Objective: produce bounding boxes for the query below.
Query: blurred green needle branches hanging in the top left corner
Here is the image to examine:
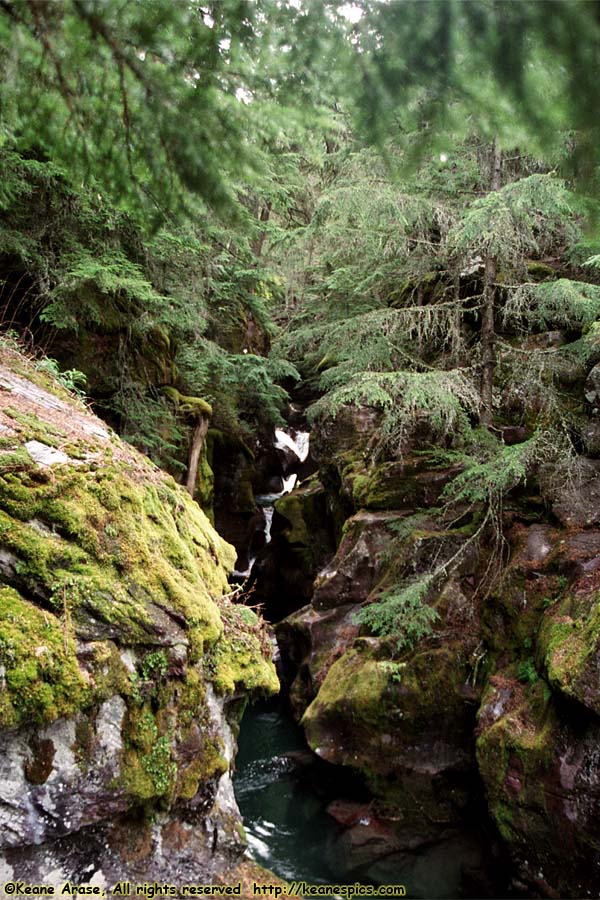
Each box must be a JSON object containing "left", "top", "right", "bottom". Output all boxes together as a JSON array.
[{"left": 0, "top": 0, "right": 338, "bottom": 221}]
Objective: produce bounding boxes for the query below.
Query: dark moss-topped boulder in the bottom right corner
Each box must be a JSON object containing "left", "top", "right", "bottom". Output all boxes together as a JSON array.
[{"left": 477, "top": 669, "right": 600, "bottom": 897}]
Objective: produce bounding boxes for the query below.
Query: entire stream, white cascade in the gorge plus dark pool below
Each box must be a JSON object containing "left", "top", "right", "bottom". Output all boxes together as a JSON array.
[{"left": 233, "top": 429, "right": 514, "bottom": 900}]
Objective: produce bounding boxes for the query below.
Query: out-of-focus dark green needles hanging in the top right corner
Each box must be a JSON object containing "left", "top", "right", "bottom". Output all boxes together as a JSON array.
[{"left": 353, "top": 0, "right": 600, "bottom": 184}]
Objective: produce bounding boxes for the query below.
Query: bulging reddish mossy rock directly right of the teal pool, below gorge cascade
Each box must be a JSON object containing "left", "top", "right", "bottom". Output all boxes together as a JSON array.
[{"left": 277, "top": 492, "right": 488, "bottom": 889}]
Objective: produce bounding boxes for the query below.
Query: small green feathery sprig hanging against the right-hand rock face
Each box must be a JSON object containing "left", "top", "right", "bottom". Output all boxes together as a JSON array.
[{"left": 358, "top": 575, "right": 439, "bottom": 653}]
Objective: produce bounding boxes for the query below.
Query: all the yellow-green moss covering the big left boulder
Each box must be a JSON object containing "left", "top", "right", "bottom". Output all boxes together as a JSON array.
[{"left": 0, "top": 344, "right": 278, "bottom": 780}]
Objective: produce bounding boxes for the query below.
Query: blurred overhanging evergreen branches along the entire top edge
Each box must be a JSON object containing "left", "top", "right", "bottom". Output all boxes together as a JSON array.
[{"left": 0, "top": 0, "right": 600, "bottom": 222}]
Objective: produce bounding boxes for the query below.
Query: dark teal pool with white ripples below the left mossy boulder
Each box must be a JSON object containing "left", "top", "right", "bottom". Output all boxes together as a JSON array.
[{"left": 234, "top": 700, "right": 352, "bottom": 884}]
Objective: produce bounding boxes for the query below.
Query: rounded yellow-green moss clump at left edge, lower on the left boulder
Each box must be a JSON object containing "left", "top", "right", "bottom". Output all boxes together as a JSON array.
[{"left": 0, "top": 587, "right": 93, "bottom": 727}]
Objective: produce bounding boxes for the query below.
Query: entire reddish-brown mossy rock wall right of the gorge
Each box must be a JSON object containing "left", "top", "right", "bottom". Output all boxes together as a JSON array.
[{"left": 277, "top": 398, "right": 600, "bottom": 897}]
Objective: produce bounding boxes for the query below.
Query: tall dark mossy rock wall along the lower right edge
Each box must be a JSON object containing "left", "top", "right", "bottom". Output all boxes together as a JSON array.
[{"left": 476, "top": 525, "right": 600, "bottom": 897}]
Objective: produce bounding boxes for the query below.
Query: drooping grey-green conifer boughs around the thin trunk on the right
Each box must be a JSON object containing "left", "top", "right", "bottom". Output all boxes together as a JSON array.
[{"left": 276, "top": 139, "right": 598, "bottom": 464}]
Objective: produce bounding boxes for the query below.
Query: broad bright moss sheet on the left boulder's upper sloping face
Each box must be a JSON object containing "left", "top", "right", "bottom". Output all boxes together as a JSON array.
[{"left": 0, "top": 458, "right": 234, "bottom": 658}]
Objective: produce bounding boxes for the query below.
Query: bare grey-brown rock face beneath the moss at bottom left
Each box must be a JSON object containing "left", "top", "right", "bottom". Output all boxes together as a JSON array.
[{"left": 0, "top": 698, "right": 243, "bottom": 887}]
